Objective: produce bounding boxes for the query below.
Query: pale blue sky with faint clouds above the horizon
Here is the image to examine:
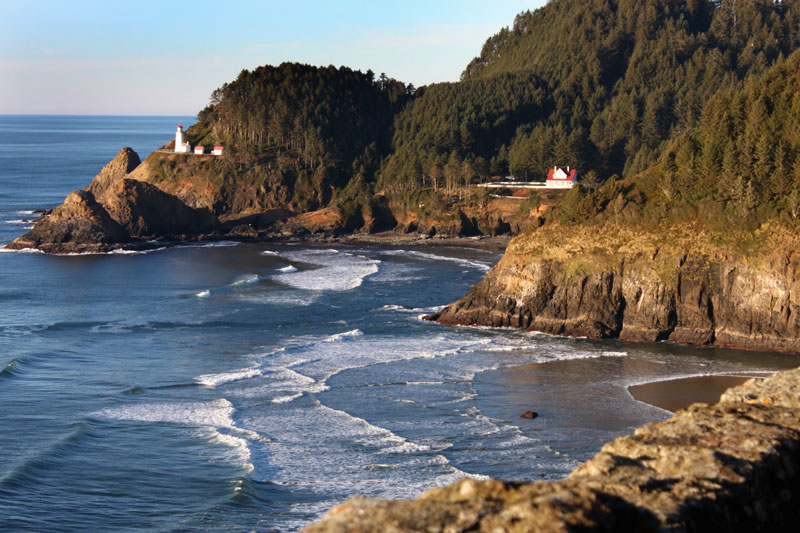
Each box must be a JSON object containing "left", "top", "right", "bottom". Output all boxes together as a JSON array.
[{"left": 0, "top": 0, "right": 546, "bottom": 115}]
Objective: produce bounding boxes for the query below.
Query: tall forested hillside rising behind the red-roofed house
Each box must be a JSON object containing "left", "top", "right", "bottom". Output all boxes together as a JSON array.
[{"left": 381, "top": 0, "right": 800, "bottom": 189}]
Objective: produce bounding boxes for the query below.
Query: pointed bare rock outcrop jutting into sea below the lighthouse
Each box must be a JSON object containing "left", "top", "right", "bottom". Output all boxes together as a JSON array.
[{"left": 6, "top": 148, "right": 217, "bottom": 253}]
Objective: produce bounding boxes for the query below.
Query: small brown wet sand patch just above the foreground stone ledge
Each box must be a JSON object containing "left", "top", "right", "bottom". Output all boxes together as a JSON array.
[{"left": 628, "top": 375, "right": 765, "bottom": 412}]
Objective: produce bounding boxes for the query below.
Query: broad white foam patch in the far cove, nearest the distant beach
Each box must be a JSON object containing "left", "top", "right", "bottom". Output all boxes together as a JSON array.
[{"left": 272, "top": 250, "right": 380, "bottom": 291}]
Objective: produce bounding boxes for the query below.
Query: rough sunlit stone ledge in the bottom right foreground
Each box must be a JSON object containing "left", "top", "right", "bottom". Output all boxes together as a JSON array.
[{"left": 306, "top": 369, "right": 800, "bottom": 533}]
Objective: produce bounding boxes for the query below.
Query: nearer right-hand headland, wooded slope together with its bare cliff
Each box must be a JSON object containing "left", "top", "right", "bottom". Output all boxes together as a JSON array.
[{"left": 434, "top": 46, "right": 800, "bottom": 352}]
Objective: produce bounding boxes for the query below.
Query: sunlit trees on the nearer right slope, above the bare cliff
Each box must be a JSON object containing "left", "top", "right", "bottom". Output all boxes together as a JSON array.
[{"left": 552, "top": 51, "right": 800, "bottom": 233}]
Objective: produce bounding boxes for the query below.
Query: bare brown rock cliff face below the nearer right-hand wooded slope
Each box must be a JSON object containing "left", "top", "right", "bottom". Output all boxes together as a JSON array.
[{"left": 432, "top": 221, "right": 800, "bottom": 352}]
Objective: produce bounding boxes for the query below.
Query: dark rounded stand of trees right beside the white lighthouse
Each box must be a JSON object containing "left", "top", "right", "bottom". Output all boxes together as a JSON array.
[{"left": 188, "top": 63, "right": 414, "bottom": 210}]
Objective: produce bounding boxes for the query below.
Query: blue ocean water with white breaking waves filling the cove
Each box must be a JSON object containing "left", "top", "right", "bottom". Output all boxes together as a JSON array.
[{"left": 0, "top": 116, "right": 798, "bottom": 531}]
